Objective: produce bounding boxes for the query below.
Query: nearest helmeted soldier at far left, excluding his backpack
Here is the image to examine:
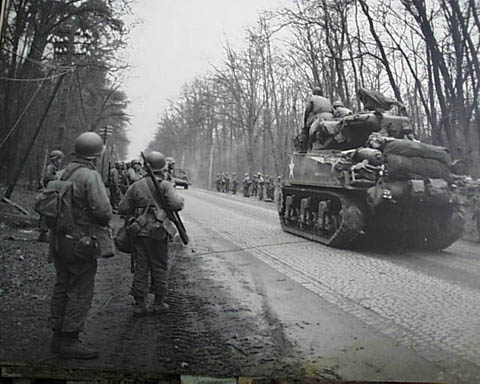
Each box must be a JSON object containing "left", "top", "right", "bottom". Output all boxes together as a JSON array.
[{"left": 50, "top": 132, "right": 112, "bottom": 359}]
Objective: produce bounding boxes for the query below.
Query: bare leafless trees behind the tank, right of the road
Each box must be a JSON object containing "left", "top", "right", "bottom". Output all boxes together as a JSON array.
[{"left": 150, "top": 0, "right": 480, "bottom": 186}]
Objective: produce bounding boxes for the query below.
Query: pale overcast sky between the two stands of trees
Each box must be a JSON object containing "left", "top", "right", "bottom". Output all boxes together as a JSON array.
[{"left": 124, "top": 0, "right": 288, "bottom": 158}]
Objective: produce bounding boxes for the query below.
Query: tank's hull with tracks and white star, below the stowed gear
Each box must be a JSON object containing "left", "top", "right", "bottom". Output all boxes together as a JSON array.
[{"left": 279, "top": 150, "right": 463, "bottom": 250}]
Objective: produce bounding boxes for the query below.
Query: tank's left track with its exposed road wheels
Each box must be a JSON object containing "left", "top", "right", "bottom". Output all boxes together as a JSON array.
[{"left": 279, "top": 187, "right": 365, "bottom": 248}]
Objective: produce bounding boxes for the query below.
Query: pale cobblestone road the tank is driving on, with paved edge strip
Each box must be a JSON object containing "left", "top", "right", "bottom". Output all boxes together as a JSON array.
[{"left": 183, "top": 189, "right": 480, "bottom": 383}]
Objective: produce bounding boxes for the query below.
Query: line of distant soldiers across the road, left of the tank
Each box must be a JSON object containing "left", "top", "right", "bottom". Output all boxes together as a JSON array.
[{"left": 215, "top": 172, "right": 282, "bottom": 201}]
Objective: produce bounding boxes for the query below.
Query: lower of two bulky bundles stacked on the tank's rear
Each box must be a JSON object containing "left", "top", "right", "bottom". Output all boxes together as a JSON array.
[{"left": 384, "top": 153, "right": 450, "bottom": 181}]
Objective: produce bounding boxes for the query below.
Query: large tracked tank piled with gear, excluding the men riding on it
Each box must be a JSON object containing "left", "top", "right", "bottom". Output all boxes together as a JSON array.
[{"left": 278, "top": 91, "right": 464, "bottom": 250}]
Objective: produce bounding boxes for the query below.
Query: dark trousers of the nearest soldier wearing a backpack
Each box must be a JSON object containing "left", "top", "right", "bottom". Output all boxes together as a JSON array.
[{"left": 50, "top": 234, "right": 97, "bottom": 332}]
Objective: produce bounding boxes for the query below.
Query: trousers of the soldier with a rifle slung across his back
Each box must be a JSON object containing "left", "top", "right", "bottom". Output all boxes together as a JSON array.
[{"left": 131, "top": 237, "right": 168, "bottom": 299}]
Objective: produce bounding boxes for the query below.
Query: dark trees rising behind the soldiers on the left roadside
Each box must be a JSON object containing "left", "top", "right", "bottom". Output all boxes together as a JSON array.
[{"left": 0, "top": 0, "right": 130, "bottom": 197}]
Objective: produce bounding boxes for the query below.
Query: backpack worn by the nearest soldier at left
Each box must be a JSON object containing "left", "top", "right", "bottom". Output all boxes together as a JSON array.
[{"left": 34, "top": 164, "right": 84, "bottom": 233}]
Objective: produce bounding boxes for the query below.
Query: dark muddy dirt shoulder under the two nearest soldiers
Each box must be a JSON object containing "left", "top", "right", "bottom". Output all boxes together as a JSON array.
[{"left": 0, "top": 188, "right": 301, "bottom": 377}]
